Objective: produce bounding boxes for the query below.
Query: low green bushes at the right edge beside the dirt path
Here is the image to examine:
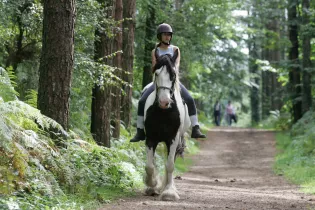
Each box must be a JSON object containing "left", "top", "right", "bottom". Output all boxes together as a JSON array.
[{"left": 275, "top": 112, "right": 315, "bottom": 193}]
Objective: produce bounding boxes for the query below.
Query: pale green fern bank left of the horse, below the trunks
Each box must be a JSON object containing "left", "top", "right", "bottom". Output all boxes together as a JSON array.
[{"left": 0, "top": 101, "right": 144, "bottom": 209}]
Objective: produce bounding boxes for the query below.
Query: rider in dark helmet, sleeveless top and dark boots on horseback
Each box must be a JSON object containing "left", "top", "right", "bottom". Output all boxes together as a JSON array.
[{"left": 130, "top": 23, "right": 206, "bottom": 142}]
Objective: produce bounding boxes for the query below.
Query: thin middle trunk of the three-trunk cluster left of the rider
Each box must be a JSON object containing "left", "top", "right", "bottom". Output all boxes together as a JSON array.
[{"left": 112, "top": 0, "right": 123, "bottom": 138}]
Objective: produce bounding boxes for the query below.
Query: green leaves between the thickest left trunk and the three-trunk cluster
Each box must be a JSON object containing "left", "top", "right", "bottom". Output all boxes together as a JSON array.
[{"left": 70, "top": 0, "right": 128, "bottom": 139}]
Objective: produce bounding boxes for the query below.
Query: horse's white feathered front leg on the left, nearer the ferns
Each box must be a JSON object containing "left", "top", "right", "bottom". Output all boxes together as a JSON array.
[{"left": 145, "top": 146, "right": 161, "bottom": 195}]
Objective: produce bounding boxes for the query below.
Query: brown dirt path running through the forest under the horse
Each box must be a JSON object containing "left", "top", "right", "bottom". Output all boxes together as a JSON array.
[{"left": 102, "top": 127, "right": 315, "bottom": 210}]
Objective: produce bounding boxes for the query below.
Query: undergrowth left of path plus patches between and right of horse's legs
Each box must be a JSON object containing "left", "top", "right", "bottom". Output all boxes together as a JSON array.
[{"left": 0, "top": 68, "right": 198, "bottom": 210}]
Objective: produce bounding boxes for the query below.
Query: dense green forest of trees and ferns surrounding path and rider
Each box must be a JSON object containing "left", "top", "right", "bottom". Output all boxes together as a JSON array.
[{"left": 0, "top": 0, "right": 315, "bottom": 209}]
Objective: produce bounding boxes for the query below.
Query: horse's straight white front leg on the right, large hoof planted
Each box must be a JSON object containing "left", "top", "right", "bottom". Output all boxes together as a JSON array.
[{"left": 160, "top": 133, "right": 179, "bottom": 201}]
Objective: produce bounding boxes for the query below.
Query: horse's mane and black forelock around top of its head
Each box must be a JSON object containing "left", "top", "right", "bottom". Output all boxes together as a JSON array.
[{"left": 153, "top": 54, "right": 180, "bottom": 90}]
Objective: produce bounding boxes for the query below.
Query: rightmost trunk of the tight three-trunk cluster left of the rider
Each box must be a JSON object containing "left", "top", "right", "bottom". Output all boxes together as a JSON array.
[{"left": 121, "top": 0, "right": 136, "bottom": 128}]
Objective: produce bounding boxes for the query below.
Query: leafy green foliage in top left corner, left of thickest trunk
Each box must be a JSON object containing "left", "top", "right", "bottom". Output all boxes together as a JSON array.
[{"left": 0, "top": 0, "right": 43, "bottom": 98}]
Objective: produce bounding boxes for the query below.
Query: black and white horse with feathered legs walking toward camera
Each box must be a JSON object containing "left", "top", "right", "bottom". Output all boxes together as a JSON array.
[{"left": 144, "top": 51, "right": 190, "bottom": 200}]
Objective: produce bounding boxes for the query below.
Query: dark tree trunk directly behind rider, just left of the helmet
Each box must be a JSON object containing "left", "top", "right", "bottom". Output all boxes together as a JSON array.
[{"left": 142, "top": 3, "right": 157, "bottom": 88}]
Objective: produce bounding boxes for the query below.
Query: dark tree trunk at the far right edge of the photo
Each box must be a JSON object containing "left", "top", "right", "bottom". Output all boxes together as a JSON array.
[{"left": 302, "top": 0, "right": 312, "bottom": 114}]
